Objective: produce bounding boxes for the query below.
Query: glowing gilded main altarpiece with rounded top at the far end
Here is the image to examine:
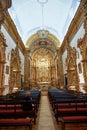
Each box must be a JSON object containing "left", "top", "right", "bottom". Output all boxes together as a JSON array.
[{"left": 31, "top": 48, "right": 56, "bottom": 88}]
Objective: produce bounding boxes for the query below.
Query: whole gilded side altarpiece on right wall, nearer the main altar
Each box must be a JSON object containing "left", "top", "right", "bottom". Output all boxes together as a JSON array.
[{"left": 66, "top": 45, "right": 78, "bottom": 91}]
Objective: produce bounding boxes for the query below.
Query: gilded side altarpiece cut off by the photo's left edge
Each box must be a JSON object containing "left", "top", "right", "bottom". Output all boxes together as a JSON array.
[{"left": 0, "top": 31, "right": 7, "bottom": 91}]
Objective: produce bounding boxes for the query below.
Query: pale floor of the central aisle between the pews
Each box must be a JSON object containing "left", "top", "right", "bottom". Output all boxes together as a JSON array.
[{"left": 38, "top": 96, "right": 55, "bottom": 130}]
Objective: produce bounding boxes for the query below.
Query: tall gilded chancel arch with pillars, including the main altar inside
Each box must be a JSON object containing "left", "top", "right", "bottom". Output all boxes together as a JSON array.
[{"left": 24, "top": 30, "right": 63, "bottom": 89}]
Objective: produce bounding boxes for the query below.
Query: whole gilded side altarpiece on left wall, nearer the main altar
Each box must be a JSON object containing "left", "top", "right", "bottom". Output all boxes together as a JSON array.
[{"left": 9, "top": 46, "right": 21, "bottom": 91}]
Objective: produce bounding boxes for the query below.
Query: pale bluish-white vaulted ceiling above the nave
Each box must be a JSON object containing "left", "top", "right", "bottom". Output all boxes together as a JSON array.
[{"left": 9, "top": 0, "right": 80, "bottom": 44}]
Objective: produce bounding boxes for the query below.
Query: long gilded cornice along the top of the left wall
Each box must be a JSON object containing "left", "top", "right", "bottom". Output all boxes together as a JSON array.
[{"left": 4, "top": 13, "right": 25, "bottom": 54}]
